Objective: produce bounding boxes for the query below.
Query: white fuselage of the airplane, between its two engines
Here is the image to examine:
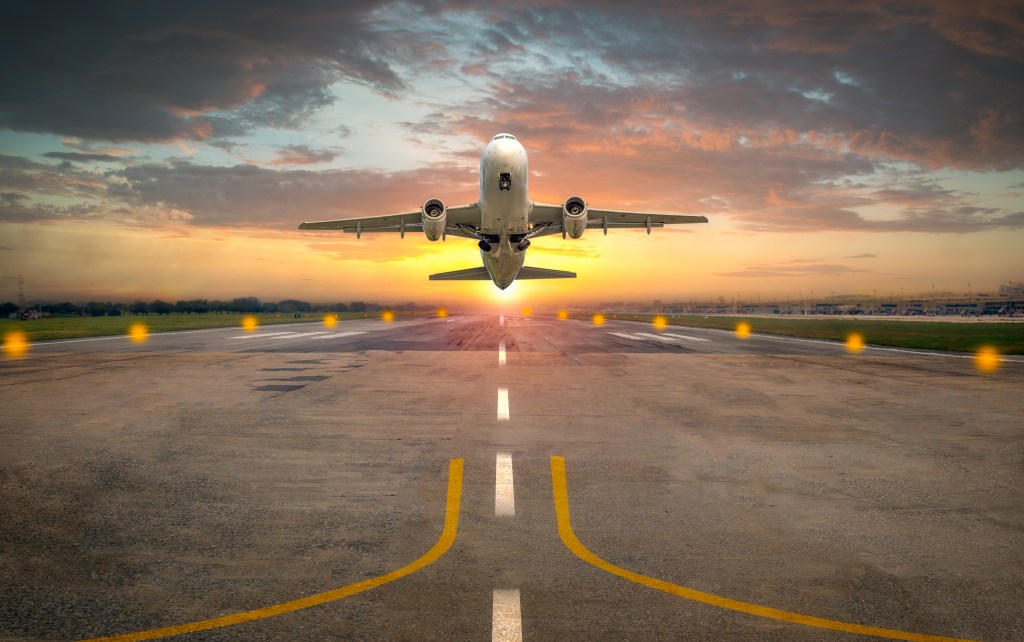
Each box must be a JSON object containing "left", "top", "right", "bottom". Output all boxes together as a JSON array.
[{"left": 479, "top": 134, "right": 532, "bottom": 290}]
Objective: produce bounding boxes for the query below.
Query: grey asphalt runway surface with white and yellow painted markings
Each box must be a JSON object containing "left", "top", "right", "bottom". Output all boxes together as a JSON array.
[{"left": 0, "top": 313, "right": 1024, "bottom": 642}]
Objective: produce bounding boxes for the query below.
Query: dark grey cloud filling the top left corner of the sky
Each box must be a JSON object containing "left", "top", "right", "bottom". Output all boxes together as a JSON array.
[{"left": 0, "top": 0, "right": 403, "bottom": 141}]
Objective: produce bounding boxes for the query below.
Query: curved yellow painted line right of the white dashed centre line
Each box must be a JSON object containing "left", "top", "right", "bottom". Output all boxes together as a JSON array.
[{"left": 551, "top": 457, "right": 969, "bottom": 642}]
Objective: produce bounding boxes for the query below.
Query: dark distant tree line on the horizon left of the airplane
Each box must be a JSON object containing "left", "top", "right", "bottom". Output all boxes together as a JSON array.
[{"left": 0, "top": 297, "right": 428, "bottom": 318}]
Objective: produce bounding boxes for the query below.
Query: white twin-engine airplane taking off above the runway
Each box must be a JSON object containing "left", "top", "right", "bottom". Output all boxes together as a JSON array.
[{"left": 299, "top": 134, "right": 708, "bottom": 290}]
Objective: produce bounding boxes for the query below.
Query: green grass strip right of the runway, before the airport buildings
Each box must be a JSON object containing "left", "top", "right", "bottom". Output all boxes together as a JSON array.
[{"left": 585, "top": 314, "right": 1024, "bottom": 354}]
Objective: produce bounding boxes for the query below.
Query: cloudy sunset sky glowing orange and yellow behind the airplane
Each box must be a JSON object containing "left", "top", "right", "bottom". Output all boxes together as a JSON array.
[{"left": 0, "top": 0, "right": 1024, "bottom": 305}]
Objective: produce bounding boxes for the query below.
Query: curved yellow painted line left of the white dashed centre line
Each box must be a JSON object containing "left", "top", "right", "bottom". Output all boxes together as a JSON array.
[{"left": 82, "top": 459, "right": 463, "bottom": 642}]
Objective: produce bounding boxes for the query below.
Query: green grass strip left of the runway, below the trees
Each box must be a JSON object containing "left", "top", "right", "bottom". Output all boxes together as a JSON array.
[{"left": 0, "top": 312, "right": 414, "bottom": 343}]
